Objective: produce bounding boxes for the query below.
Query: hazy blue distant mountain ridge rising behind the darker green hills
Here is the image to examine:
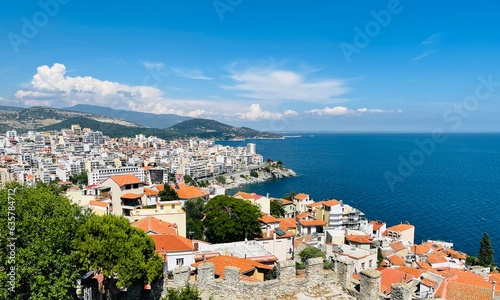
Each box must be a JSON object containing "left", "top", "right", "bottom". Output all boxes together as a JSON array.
[{"left": 66, "top": 104, "right": 191, "bottom": 128}]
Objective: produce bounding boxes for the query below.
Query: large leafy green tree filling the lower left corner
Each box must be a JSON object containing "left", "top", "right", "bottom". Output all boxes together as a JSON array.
[{"left": 0, "top": 183, "right": 90, "bottom": 300}]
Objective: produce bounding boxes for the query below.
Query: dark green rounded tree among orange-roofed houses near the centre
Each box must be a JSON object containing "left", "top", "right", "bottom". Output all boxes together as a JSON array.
[{"left": 203, "top": 195, "right": 262, "bottom": 243}]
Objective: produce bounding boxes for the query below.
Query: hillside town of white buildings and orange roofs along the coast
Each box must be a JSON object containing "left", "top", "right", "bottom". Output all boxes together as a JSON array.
[{"left": 0, "top": 125, "right": 500, "bottom": 300}]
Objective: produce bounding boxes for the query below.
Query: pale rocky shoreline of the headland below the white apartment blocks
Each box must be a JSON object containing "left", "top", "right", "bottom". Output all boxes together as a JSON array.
[{"left": 218, "top": 163, "right": 297, "bottom": 189}]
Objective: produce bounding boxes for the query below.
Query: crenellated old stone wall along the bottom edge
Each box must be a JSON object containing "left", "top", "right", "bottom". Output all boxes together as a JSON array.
[{"left": 174, "top": 258, "right": 354, "bottom": 300}]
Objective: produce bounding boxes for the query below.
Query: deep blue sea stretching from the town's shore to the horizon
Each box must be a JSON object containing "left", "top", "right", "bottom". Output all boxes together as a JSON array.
[{"left": 217, "top": 133, "right": 500, "bottom": 262}]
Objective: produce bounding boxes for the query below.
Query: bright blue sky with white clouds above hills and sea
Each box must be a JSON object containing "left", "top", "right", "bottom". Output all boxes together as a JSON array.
[{"left": 0, "top": 0, "right": 500, "bottom": 132}]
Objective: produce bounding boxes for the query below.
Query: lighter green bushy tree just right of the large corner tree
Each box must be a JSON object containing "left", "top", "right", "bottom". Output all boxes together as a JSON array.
[{"left": 73, "top": 215, "right": 163, "bottom": 293}]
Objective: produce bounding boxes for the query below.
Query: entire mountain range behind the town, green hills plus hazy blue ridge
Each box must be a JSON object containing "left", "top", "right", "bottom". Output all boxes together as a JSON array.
[{"left": 0, "top": 105, "right": 281, "bottom": 140}]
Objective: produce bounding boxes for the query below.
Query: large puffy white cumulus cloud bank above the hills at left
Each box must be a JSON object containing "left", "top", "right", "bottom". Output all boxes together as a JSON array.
[{"left": 15, "top": 63, "right": 218, "bottom": 116}]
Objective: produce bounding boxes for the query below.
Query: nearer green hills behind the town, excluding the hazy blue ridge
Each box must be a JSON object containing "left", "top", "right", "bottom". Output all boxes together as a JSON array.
[{"left": 0, "top": 106, "right": 281, "bottom": 140}]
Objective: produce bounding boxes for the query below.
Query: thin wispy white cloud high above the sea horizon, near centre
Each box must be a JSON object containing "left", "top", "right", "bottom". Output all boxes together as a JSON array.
[{"left": 222, "top": 69, "right": 349, "bottom": 103}]
